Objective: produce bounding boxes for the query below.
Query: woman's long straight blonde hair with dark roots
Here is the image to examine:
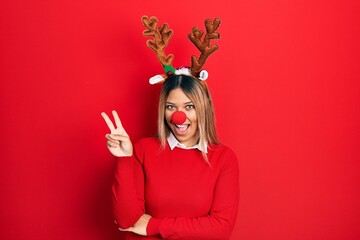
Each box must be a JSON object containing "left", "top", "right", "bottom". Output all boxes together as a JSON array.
[{"left": 158, "top": 75, "right": 219, "bottom": 160}]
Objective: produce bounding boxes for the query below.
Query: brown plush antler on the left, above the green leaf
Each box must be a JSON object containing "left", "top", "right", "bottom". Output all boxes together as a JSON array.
[{"left": 141, "top": 16, "right": 174, "bottom": 66}]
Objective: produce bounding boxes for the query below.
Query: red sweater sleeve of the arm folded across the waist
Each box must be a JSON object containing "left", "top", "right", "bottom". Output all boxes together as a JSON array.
[{"left": 147, "top": 149, "right": 239, "bottom": 239}]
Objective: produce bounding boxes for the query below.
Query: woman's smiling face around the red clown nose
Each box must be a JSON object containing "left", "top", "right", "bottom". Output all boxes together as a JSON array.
[{"left": 165, "top": 88, "right": 199, "bottom": 147}]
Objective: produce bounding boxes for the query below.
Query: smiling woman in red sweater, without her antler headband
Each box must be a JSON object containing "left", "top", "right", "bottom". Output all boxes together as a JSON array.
[{"left": 102, "top": 75, "right": 239, "bottom": 239}]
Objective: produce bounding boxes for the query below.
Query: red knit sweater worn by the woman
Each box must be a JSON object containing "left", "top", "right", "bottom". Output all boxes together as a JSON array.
[{"left": 112, "top": 138, "right": 239, "bottom": 240}]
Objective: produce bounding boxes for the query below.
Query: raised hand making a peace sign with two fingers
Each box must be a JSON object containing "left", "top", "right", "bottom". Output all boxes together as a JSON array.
[{"left": 101, "top": 110, "right": 133, "bottom": 157}]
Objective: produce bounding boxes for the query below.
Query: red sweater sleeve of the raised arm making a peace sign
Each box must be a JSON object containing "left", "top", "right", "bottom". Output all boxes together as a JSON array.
[{"left": 112, "top": 142, "right": 145, "bottom": 228}]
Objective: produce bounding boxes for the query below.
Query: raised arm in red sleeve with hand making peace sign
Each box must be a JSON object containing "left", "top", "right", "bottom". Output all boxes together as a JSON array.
[{"left": 101, "top": 111, "right": 144, "bottom": 228}]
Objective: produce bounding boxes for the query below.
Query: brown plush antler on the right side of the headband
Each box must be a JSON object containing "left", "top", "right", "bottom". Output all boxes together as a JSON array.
[{"left": 188, "top": 18, "right": 221, "bottom": 76}]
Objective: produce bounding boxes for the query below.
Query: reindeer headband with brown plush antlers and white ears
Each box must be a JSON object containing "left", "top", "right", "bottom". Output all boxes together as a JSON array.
[{"left": 142, "top": 16, "right": 221, "bottom": 84}]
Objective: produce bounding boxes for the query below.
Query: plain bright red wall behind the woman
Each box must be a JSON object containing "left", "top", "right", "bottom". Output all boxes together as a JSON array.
[{"left": 0, "top": 0, "right": 360, "bottom": 240}]
